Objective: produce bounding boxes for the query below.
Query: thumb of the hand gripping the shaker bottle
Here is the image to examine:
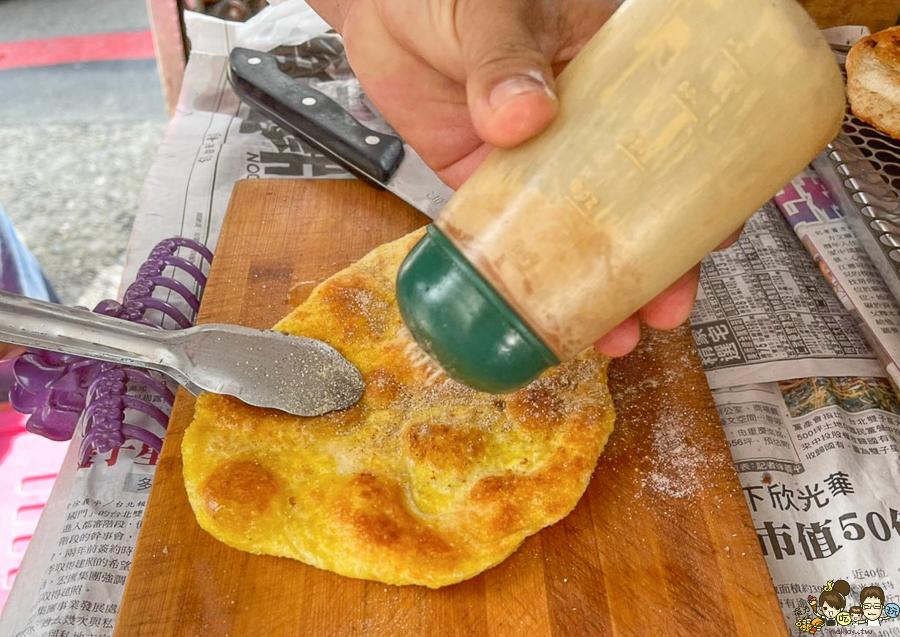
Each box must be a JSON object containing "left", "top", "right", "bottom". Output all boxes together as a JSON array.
[{"left": 458, "top": 0, "right": 559, "bottom": 148}]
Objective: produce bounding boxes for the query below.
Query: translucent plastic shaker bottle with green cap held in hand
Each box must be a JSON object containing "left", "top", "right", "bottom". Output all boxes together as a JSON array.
[{"left": 397, "top": 0, "right": 844, "bottom": 393}]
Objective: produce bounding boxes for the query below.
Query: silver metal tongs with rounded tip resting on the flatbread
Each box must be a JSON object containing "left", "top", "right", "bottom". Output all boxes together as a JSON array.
[{"left": 0, "top": 291, "right": 365, "bottom": 416}]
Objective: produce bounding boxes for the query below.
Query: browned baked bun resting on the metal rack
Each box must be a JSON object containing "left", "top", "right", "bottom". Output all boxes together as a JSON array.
[{"left": 847, "top": 27, "right": 900, "bottom": 139}]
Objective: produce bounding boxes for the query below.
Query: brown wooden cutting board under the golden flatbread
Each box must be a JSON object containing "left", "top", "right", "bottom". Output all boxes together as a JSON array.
[{"left": 115, "top": 181, "right": 787, "bottom": 637}]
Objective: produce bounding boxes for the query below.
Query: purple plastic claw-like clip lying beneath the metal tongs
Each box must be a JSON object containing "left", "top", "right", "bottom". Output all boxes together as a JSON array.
[{"left": 10, "top": 238, "right": 213, "bottom": 466}]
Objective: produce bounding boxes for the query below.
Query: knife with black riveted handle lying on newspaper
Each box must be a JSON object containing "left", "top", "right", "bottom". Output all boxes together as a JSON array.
[{"left": 229, "top": 48, "right": 453, "bottom": 219}]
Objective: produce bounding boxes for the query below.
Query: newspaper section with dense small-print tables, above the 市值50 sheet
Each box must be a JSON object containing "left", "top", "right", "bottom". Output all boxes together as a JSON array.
[{"left": 691, "top": 203, "right": 884, "bottom": 388}]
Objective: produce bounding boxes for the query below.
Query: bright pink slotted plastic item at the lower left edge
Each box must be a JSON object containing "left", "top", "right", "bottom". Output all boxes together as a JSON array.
[{"left": 0, "top": 403, "right": 68, "bottom": 610}]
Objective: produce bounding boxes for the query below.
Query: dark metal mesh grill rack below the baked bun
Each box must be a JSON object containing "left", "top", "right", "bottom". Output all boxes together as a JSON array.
[{"left": 813, "top": 46, "right": 900, "bottom": 301}]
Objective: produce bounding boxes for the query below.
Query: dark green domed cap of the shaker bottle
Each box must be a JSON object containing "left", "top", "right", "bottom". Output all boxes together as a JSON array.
[{"left": 397, "top": 225, "right": 559, "bottom": 394}]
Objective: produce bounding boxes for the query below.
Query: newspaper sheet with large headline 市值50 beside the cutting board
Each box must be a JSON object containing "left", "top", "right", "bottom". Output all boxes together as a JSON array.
[{"left": 713, "top": 377, "right": 900, "bottom": 635}]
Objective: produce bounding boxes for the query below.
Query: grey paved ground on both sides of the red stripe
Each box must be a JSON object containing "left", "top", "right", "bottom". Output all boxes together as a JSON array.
[{"left": 0, "top": 0, "right": 167, "bottom": 306}]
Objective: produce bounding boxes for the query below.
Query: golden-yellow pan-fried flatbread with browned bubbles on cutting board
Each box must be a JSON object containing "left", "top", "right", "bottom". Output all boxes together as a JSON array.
[{"left": 182, "top": 231, "right": 614, "bottom": 587}]
